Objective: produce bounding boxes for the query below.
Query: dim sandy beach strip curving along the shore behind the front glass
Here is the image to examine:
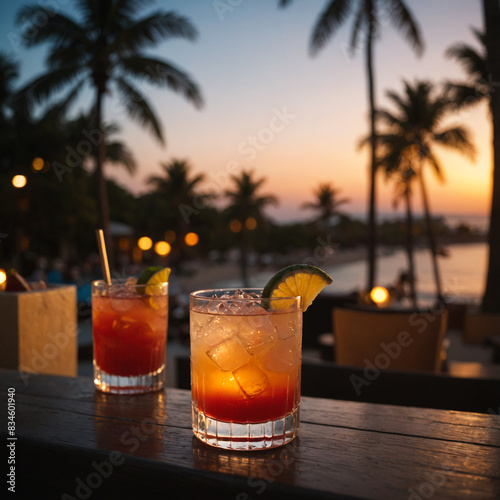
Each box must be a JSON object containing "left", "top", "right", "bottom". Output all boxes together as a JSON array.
[{"left": 172, "top": 248, "right": 366, "bottom": 293}]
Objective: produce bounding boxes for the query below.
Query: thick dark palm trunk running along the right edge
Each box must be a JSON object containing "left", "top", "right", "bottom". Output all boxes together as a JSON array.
[{"left": 481, "top": 0, "right": 500, "bottom": 313}]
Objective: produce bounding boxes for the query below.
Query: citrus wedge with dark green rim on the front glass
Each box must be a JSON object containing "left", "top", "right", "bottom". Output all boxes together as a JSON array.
[{"left": 262, "top": 264, "right": 332, "bottom": 311}]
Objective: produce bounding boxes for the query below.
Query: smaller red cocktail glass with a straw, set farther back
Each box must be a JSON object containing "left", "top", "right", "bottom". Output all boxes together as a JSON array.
[{"left": 92, "top": 278, "right": 168, "bottom": 394}]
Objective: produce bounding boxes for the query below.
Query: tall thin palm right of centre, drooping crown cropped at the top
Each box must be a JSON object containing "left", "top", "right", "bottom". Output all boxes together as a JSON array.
[{"left": 280, "top": 0, "right": 423, "bottom": 290}]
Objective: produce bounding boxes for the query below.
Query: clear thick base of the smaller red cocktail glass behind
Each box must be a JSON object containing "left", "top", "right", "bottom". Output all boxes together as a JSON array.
[{"left": 94, "top": 361, "right": 165, "bottom": 394}]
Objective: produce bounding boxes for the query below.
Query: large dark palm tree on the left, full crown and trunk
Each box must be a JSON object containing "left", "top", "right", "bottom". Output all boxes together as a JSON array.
[{"left": 18, "top": 0, "right": 202, "bottom": 258}]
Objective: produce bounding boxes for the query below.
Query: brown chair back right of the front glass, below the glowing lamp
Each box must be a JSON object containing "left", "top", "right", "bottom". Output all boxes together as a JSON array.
[{"left": 333, "top": 308, "right": 448, "bottom": 372}]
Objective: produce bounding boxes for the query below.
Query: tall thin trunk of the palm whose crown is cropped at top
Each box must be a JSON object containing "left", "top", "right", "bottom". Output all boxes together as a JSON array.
[{"left": 366, "top": 9, "right": 377, "bottom": 291}]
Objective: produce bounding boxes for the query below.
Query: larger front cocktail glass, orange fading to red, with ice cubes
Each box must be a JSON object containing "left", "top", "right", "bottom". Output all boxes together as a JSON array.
[{"left": 190, "top": 289, "right": 302, "bottom": 450}]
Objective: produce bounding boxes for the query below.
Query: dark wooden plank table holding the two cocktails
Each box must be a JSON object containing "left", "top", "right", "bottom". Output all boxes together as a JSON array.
[{"left": 0, "top": 371, "right": 500, "bottom": 500}]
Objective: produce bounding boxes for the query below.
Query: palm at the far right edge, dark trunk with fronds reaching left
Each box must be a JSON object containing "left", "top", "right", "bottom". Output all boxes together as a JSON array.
[{"left": 446, "top": 6, "right": 500, "bottom": 313}]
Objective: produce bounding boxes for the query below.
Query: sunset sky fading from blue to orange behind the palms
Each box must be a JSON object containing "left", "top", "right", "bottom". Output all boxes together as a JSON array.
[{"left": 0, "top": 0, "right": 491, "bottom": 221}]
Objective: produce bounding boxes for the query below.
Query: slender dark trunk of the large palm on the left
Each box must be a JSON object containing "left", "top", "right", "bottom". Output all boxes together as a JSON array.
[{"left": 95, "top": 85, "right": 114, "bottom": 268}]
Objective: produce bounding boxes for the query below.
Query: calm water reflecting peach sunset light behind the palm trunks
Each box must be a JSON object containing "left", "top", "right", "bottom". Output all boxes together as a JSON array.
[{"left": 222, "top": 243, "right": 488, "bottom": 306}]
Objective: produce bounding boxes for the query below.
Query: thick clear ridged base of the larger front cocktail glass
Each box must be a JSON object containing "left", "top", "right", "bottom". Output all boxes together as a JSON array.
[{"left": 192, "top": 403, "right": 300, "bottom": 451}]
